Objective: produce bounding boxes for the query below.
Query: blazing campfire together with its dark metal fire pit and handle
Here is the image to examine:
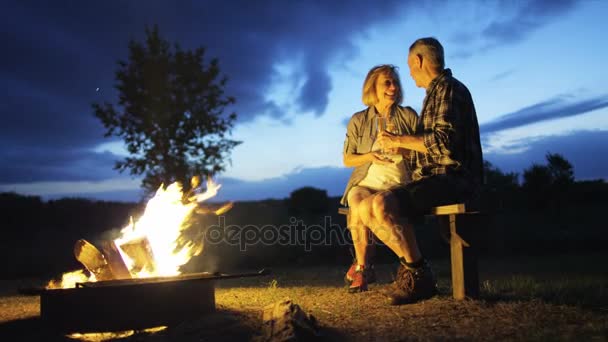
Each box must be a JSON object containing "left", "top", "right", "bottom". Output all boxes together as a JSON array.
[{"left": 27, "top": 178, "right": 268, "bottom": 332}]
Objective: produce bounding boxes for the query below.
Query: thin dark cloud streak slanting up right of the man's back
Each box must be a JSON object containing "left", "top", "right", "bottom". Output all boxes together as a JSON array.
[{"left": 480, "top": 95, "right": 608, "bottom": 135}]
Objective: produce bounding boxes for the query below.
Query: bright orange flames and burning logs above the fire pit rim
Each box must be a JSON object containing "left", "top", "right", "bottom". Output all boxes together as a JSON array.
[{"left": 47, "top": 177, "right": 232, "bottom": 289}]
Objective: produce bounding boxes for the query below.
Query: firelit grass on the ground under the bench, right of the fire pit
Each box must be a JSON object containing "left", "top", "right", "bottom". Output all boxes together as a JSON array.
[{"left": 207, "top": 255, "right": 608, "bottom": 340}]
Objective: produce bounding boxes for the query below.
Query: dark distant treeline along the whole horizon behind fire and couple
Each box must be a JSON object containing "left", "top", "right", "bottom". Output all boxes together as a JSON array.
[{"left": 0, "top": 154, "right": 608, "bottom": 277}]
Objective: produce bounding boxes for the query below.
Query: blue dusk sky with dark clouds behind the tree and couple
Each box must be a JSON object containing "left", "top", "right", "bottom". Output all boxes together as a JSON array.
[{"left": 0, "top": 0, "right": 608, "bottom": 200}]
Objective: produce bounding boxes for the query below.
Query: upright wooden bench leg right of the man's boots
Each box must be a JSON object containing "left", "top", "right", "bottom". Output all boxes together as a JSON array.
[{"left": 449, "top": 214, "right": 479, "bottom": 300}]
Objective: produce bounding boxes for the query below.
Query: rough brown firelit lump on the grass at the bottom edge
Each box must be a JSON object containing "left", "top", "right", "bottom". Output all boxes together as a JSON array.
[{"left": 262, "top": 299, "right": 320, "bottom": 342}]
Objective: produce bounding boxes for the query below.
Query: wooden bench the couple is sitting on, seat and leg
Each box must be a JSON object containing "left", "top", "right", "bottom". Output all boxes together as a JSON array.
[{"left": 338, "top": 203, "right": 479, "bottom": 300}]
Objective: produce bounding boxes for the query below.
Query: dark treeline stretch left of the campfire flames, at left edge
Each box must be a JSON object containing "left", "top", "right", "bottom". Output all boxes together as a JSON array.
[{"left": 0, "top": 193, "right": 140, "bottom": 277}]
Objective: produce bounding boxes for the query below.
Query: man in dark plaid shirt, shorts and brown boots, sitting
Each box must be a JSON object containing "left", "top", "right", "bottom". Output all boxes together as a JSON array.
[{"left": 361, "top": 38, "right": 483, "bottom": 305}]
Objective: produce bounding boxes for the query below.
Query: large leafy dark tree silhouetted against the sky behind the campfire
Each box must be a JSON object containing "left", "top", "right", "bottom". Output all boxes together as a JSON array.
[{"left": 93, "top": 26, "right": 240, "bottom": 192}]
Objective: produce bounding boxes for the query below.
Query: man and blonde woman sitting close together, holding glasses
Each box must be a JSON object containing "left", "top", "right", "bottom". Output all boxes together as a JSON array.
[{"left": 341, "top": 38, "right": 483, "bottom": 305}]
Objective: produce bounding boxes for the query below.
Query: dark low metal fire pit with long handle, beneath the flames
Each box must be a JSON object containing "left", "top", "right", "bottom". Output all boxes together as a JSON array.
[{"left": 29, "top": 270, "right": 269, "bottom": 332}]
